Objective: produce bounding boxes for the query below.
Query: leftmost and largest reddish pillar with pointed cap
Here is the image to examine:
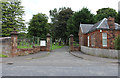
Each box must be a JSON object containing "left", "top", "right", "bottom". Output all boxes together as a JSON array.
[{"left": 11, "top": 28, "right": 18, "bottom": 57}]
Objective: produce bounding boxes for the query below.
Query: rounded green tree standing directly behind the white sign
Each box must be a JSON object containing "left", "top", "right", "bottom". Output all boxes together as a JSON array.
[{"left": 28, "top": 13, "right": 48, "bottom": 38}]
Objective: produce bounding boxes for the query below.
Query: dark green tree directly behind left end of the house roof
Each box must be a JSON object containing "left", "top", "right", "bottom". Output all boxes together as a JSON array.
[{"left": 66, "top": 8, "right": 95, "bottom": 40}]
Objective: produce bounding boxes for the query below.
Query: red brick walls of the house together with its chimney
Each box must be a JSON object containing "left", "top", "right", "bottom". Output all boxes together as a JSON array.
[{"left": 79, "top": 17, "right": 120, "bottom": 49}]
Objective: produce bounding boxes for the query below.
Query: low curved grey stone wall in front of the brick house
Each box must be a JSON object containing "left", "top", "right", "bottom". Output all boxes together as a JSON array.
[{"left": 81, "top": 46, "right": 120, "bottom": 58}]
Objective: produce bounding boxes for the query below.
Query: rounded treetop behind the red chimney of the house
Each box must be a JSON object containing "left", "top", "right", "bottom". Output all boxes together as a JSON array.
[{"left": 95, "top": 8, "right": 117, "bottom": 22}]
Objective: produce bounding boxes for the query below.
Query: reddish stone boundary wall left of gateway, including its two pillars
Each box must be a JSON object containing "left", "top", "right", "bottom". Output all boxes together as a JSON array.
[{"left": 0, "top": 28, "right": 51, "bottom": 57}]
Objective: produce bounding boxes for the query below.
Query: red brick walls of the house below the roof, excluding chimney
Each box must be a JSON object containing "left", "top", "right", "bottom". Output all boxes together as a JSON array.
[{"left": 79, "top": 30, "right": 120, "bottom": 49}]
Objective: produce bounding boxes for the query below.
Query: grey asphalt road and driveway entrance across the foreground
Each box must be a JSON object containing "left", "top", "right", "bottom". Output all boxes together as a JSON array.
[{"left": 2, "top": 46, "right": 118, "bottom": 76}]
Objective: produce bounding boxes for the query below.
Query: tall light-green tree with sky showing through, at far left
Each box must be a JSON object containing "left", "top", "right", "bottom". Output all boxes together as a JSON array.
[{"left": 1, "top": 0, "right": 26, "bottom": 37}]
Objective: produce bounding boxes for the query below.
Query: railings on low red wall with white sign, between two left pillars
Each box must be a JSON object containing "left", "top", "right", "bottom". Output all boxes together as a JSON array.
[{"left": 17, "top": 37, "right": 50, "bottom": 55}]
